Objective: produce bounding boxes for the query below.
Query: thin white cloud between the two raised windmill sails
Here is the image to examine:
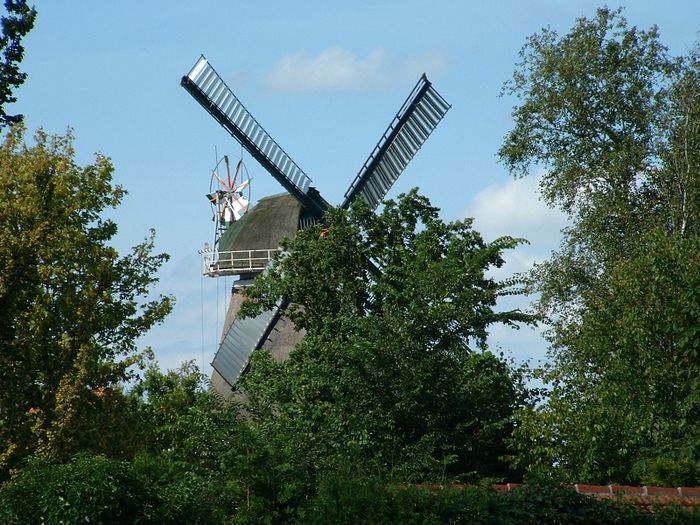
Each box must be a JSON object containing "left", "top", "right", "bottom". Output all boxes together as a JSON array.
[{"left": 266, "top": 47, "right": 447, "bottom": 92}]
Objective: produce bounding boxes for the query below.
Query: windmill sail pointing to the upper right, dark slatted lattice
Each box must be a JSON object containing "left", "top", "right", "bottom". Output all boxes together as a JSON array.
[{"left": 341, "top": 74, "right": 450, "bottom": 209}]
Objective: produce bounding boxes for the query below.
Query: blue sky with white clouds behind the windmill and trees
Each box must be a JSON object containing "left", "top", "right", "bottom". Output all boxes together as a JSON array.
[{"left": 8, "top": 0, "right": 700, "bottom": 368}]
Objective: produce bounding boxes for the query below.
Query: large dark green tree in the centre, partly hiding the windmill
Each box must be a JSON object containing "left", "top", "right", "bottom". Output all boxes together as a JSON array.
[{"left": 232, "top": 192, "right": 532, "bottom": 516}]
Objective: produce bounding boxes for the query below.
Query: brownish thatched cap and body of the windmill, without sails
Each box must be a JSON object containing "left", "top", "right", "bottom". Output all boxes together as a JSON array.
[{"left": 211, "top": 193, "right": 304, "bottom": 399}]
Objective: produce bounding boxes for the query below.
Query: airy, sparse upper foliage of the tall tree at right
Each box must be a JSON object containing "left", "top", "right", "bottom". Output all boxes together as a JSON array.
[{"left": 499, "top": 9, "right": 700, "bottom": 324}]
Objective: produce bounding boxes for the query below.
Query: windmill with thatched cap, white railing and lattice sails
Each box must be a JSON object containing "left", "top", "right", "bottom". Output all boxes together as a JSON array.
[{"left": 181, "top": 56, "right": 450, "bottom": 396}]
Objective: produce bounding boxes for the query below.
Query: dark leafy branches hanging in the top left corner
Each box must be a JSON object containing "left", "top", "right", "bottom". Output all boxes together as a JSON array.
[{"left": 0, "top": 0, "right": 36, "bottom": 129}]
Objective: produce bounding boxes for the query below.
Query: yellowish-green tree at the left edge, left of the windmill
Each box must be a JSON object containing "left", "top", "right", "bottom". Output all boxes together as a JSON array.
[{"left": 0, "top": 126, "right": 171, "bottom": 476}]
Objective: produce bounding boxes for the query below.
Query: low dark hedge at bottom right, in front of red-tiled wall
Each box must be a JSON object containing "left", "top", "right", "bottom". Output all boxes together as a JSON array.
[{"left": 297, "top": 476, "right": 698, "bottom": 525}]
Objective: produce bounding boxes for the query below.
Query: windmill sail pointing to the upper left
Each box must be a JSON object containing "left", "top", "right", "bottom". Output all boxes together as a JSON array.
[{"left": 180, "top": 56, "right": 328, "bottom": 219}]
